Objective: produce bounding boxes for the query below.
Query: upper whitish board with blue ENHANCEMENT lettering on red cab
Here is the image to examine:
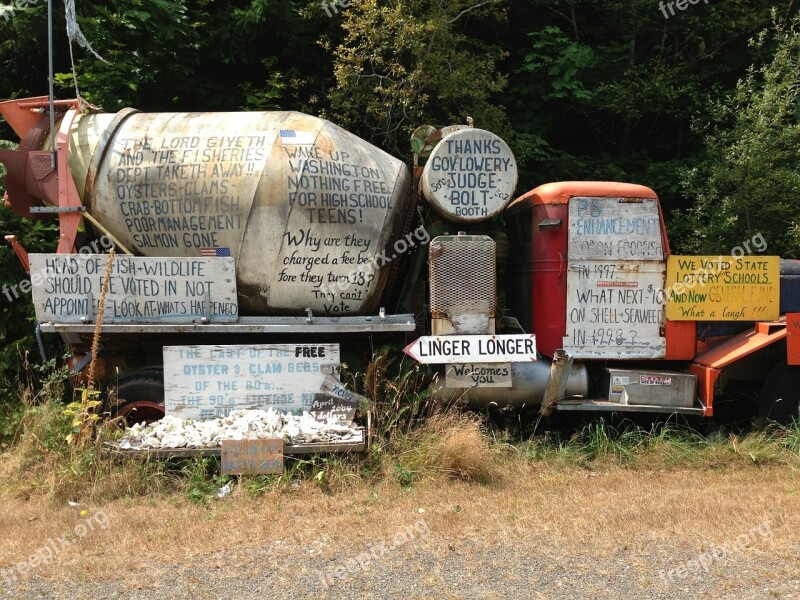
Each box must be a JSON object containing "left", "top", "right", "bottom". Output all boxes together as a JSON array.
[{"left": 568, "top": 198, "right": 664, "bottom": 261}]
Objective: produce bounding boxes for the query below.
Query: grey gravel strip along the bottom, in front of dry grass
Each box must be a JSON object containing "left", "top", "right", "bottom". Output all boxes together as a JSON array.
[{"left": 0, "top": 521, "right": 800, "bottom": 600}]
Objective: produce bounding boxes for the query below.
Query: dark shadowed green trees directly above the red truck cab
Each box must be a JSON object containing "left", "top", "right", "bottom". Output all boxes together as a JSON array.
[{"left": 502, "top": 0, "right": 788, "bottom": 200}]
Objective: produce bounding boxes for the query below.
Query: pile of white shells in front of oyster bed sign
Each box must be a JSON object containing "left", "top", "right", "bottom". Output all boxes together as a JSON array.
[{"left": 119, "top": 408, "right": 361, "bottom": 450}]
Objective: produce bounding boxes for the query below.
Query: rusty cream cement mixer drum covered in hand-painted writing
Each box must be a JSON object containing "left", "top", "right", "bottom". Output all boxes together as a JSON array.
[{"left": 62, "top": 110, "right": 410, "bottom": 315}]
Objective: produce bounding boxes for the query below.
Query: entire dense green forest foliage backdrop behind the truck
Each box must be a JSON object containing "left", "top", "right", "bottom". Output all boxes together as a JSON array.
[{"left": 0, "top": 0, "right": 800, "bottom": 406}]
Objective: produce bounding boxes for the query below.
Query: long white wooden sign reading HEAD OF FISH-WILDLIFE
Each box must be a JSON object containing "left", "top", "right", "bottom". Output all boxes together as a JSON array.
[{"left": 30, "top": 254, "right": 239, "bottom": 323}]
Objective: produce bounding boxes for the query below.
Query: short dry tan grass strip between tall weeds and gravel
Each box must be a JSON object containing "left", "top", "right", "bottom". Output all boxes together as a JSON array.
[{"left": 0, "top": 465, "right": 800, "bottom": 584}]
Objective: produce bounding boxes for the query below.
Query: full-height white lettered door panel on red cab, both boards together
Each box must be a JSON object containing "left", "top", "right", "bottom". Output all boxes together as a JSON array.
[{"left": 563, "top": 197, "right": 666, "bottom": 359}]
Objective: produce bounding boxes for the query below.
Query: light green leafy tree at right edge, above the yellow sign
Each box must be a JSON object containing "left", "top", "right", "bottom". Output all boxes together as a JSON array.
[{"left": 677, "top": 17, "right": 800, "bottom": 253}]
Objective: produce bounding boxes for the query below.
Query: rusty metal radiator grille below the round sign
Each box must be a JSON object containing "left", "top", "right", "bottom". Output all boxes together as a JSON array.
[{"left": 428, "top": 235, "right": 497, "bottom": 318}]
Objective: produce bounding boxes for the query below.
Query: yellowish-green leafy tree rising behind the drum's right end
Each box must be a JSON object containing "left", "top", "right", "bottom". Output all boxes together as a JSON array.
[{"left": 331, "top": 0, "right": 506, "bottom": 155}]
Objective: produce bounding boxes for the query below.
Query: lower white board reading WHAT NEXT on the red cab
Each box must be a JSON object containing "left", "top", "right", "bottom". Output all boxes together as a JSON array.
[{"left": 563, "top": 260, "right": 666, "bottom": 358}]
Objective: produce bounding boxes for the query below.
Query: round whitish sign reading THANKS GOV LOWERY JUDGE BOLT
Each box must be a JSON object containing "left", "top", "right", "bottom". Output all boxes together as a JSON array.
[{"left": 422, "top": 129, "right": 517, "bottom": 223}]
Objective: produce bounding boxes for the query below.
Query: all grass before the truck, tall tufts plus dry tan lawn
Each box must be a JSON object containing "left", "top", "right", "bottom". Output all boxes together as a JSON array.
[{"left": 0, "top": 398, "right": 800, "bottom": 588}]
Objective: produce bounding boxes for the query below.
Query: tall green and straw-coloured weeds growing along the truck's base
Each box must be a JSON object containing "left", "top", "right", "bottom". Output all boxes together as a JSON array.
[{"left": 0, "top": 360, "right": 800, "bottom": 504}]
